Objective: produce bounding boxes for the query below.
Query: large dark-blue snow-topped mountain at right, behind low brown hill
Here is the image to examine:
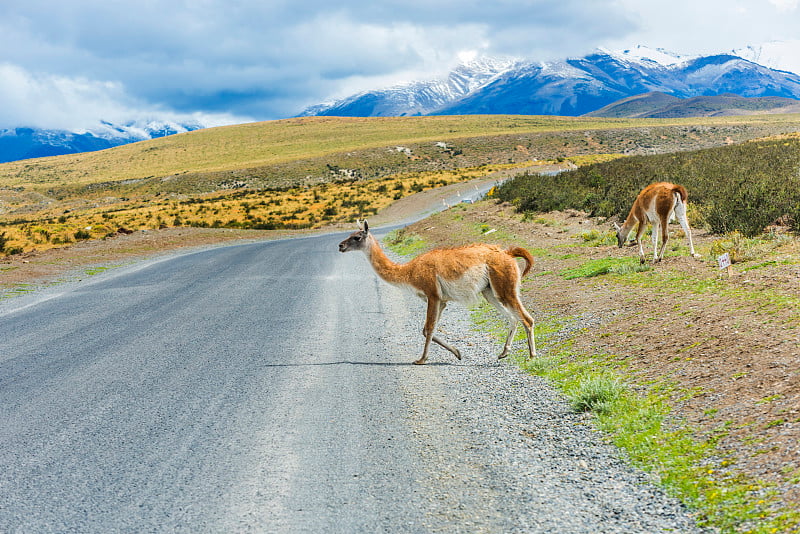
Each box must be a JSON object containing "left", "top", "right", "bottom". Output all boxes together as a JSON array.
[{"left": 438, "top": 52, "right": 800, "bottom": 115}]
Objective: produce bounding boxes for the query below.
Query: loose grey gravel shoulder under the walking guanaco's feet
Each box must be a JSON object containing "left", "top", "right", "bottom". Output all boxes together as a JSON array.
[{"left": 387, "top": 249, "right": 708, "bottom": 534}]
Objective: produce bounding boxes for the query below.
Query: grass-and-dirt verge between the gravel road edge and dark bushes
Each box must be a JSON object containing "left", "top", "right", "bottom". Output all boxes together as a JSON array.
[{"left": 394, "top": 203, "right": 800, "bottom": 534}]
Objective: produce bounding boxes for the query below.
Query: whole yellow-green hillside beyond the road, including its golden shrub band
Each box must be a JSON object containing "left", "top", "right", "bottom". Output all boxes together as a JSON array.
[{"left": 0, "top": 115, "right": 800, "bottom": 254}]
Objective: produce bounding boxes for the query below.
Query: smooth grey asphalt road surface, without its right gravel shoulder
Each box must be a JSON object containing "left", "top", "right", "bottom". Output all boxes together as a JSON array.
[{"left": 0, "top": 231, "right": 444, "bottom": 532}]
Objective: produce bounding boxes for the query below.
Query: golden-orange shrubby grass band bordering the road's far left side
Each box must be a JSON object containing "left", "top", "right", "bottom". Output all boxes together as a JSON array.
[{"left": 2, "top": 161, "right": 536, "bottom": 253}]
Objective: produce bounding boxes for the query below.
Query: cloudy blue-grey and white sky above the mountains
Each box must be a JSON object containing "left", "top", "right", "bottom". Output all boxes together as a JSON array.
[{"left": 0, "top": 0, "right": 800, "bottom": 129}]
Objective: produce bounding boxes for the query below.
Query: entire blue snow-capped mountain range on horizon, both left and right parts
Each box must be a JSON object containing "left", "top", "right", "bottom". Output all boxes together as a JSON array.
[{"left": 0, "top": 41, "right": 800, "bottom": 162}]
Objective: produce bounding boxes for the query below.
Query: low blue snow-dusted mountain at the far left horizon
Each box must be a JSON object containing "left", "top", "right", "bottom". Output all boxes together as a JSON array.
[{"left": 0, "top": 119, "right": 206, "bottom": 163}]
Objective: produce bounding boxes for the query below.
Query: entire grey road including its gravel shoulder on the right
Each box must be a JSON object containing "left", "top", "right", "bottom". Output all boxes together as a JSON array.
[{"left": 0, "top": 226, "right": 693, "bottom": 533}]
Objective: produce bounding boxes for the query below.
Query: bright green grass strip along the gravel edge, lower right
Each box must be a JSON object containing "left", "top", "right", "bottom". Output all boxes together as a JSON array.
[{"left": 473, "top": 306, "right": 800, "bottom": 534}]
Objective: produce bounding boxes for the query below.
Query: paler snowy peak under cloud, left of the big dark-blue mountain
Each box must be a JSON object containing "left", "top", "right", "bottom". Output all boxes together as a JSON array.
[{"left": 300, "top": 58, "right": 515, "bottom": 117}]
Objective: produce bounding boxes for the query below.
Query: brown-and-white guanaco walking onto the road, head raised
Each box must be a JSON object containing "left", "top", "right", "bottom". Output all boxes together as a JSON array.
[{"left": 339, "top": 220, "right": 536, "bottom": 365}]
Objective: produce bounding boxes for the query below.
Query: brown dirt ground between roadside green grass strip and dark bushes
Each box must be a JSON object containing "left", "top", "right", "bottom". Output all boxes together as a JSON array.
[{"left": 409, "top": 201, "right": 800, "bottom": 507}]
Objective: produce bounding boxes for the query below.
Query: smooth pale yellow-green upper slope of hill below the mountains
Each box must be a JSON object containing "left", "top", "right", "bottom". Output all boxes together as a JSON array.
[{"left": 0, "top": 114, "right": 800, "bottom": 187}]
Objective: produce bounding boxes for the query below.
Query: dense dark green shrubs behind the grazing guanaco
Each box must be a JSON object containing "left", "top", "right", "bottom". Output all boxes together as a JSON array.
[{"left": 497, "top": 138, "right": 800, "bottom": 236}]
